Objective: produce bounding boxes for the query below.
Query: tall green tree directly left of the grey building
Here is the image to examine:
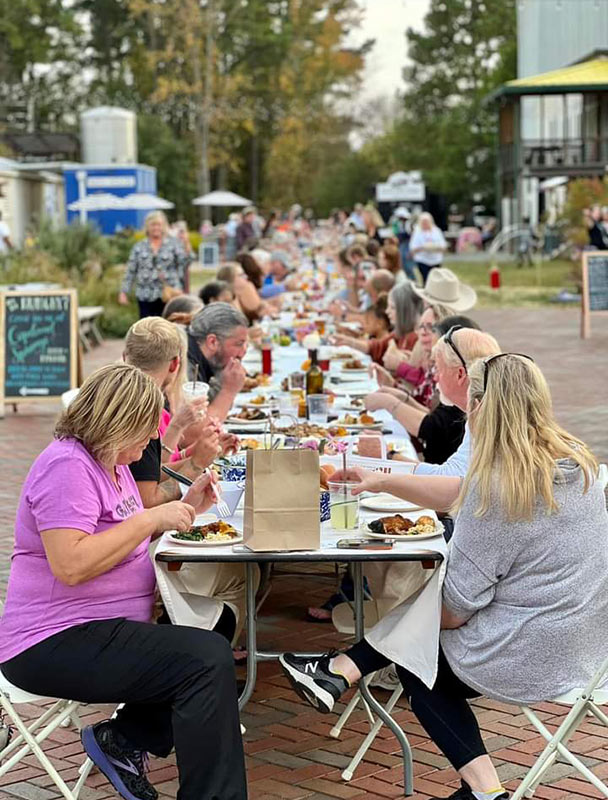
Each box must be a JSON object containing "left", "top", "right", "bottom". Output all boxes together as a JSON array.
[{"left": 398, "top": 0, "right": 516, "bottom": 211}]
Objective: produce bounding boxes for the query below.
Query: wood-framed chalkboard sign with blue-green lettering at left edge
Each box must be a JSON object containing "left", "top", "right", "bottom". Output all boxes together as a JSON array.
[{"left": 0, "top": 289, "right": 78, "bottom": 404}]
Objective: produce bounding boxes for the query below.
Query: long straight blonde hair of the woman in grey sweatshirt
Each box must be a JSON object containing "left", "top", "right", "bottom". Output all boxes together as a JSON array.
[{"left": 455, "top": 354, "right": 597, "bottom": 522}]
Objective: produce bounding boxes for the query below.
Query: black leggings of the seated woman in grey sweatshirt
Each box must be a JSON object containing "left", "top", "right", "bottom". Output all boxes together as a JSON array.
[{"left": 345, "top": 639, "right": 487, "bottom": 769}]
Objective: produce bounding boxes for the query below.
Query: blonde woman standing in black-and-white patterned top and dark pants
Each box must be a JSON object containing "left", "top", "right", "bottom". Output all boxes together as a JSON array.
[{"left": 118, "top": 211, "right": 190, "bottom": 319}]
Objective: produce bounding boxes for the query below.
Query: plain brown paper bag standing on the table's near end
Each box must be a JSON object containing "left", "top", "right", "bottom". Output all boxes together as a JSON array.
[{"left": 243, "top": 449, "right": 321, "bottom": 551}]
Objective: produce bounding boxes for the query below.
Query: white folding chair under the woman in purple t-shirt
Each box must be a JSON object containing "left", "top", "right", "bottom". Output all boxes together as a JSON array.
[{"left": 0, "top": 671, "right": 93, "bottom": 800}]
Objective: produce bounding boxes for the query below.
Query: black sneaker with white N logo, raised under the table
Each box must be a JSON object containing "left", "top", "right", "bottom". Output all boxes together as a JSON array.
[{"left": 279, "top": 653, "right": 350, "bottom": 714}]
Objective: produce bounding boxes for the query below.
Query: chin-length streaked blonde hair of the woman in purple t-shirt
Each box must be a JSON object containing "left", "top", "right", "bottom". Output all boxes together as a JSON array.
[{"left": 55, "top": 364, "right": 163, "bottom": 467}]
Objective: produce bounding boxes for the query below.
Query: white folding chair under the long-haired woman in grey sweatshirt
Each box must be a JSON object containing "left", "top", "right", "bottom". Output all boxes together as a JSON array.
[{"left": 512, "top": 658, "right": 608, "bottom": 800}]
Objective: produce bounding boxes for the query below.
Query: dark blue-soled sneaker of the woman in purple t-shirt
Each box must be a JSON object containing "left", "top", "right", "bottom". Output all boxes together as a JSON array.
[{"left": 80, "top": 722, "right": 158, "bottom": 800}]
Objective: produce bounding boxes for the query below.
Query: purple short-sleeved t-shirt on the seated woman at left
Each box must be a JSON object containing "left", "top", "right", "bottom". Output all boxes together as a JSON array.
[{"left": 0, "top": 439, "right": 155, "bottom": 663}]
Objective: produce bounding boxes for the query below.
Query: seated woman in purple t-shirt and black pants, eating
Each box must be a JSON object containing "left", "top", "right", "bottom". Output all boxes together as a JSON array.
[{"left": 0, "top": 364, "right": 247, "bottom": 800}]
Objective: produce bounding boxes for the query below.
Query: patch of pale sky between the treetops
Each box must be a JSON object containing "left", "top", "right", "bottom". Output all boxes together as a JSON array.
[{"left": 353, "top": 0, "right": 430, "bottom": 99}]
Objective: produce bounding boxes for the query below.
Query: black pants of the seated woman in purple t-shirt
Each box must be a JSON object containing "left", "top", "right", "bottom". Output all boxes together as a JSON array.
[{"left": 2, "top": 619, "right": 247, "bottom": 800}]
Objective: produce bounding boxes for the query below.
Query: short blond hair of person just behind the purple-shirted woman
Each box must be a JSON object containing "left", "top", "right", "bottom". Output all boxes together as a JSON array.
[{"left": 125, "top": 317, "right": 182, "bottom": 372}]
